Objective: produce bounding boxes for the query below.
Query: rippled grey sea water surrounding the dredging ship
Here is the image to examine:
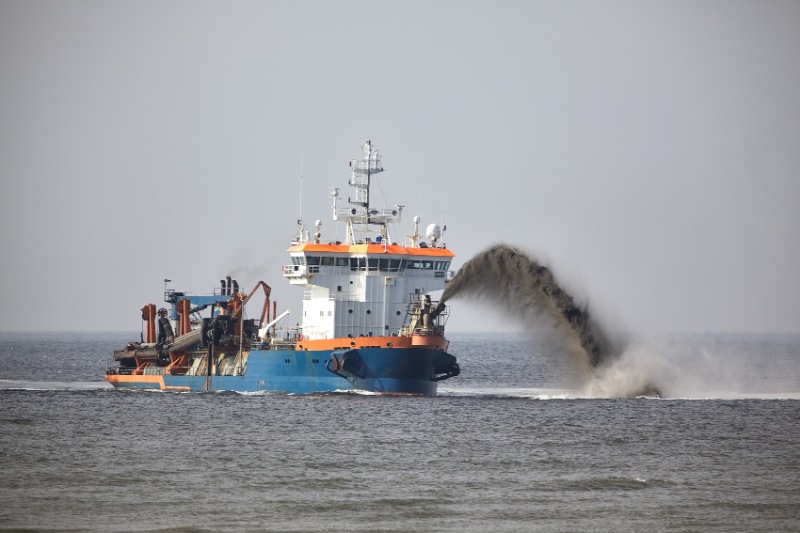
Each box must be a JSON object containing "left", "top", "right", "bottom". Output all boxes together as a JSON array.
[{"left": 0, "top": 333, "right": 800, "bottom": 533}]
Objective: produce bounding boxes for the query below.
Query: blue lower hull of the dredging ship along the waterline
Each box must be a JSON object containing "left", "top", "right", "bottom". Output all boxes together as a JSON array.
[{"left": 108, "top": 347, "right": 458, "bottom": 396}]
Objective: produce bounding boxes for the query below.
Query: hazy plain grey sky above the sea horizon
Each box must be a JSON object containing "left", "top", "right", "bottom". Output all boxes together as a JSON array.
[{"left": 0, "top": 0, "right": 800, "bottom": 331}]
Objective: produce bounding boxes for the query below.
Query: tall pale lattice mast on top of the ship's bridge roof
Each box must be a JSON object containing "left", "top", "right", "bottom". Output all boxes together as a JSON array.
[{"left": 333, "top": 140, "right": 403, "bottom": 244}]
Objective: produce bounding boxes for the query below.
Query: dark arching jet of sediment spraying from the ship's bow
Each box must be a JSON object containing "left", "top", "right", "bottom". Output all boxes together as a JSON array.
[{"left": 441, "top": 244, "right": 614, "bottom": 367}]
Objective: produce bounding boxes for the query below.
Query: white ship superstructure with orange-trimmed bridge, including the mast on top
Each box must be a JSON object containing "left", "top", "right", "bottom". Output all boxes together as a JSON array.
[{"left": 283, "top": 141, "right": 454, "bottom": 339}]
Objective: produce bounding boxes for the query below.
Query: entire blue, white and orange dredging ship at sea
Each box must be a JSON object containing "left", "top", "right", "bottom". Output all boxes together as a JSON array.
[{"left": 106, "top": 141, "right": 459, "bottom": 395}]
